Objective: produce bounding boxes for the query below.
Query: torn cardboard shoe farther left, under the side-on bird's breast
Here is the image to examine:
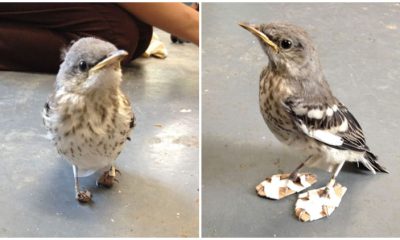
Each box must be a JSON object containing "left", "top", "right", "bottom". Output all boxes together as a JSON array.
[{"left": 256, "top": 173, "right": 317, "bottom": 199}]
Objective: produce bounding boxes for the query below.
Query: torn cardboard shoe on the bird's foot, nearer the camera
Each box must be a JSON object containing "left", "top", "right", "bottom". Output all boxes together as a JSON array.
[{"left": 295, "top": 181, "right": 347, "bottom": 222}]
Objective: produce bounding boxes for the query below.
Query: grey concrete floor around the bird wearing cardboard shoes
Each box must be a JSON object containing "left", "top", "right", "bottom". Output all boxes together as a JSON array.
[{"left": 202, "top": 3, "right": 400, "bottom": 237}]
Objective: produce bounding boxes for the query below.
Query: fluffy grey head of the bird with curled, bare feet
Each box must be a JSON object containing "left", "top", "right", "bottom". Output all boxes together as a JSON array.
[{"left": 57, "top": 37, "right": 128, "bottom": 94}]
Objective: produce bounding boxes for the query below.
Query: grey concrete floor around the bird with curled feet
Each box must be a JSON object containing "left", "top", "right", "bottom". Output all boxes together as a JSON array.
[{"left": 0, "top": 31, "right": 199, "bottom": 237}]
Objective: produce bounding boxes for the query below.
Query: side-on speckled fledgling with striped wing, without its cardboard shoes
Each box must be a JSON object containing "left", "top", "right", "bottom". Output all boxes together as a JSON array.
[{"left": 240, "top": 23, "right": 387, "bottom": 192}]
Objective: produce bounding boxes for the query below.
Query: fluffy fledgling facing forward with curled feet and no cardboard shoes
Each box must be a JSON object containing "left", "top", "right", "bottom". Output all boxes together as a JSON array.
[{"left": 42, "top": 37, "right": 135, "bottom": 203}]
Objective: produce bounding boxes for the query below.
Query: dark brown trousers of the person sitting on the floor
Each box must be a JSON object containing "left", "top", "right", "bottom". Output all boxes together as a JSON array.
[{"left": 0, "top": 3, "right": 152, "bottom": 73}]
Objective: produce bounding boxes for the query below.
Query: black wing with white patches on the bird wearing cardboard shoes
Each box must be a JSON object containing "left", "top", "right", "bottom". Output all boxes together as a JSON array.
[{"left": 283, "top": 98, "right": 369, "bottom": 152}]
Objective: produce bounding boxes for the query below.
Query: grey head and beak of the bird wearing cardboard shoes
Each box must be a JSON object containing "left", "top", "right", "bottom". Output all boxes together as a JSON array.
[{"left": 239, "top": 23, "right": 319, "bottom": 75}]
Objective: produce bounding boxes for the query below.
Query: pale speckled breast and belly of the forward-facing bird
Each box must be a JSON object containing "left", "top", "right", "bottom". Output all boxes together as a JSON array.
[{"left": 48, "top": 92, "right": 132, "bottom": 170}]
